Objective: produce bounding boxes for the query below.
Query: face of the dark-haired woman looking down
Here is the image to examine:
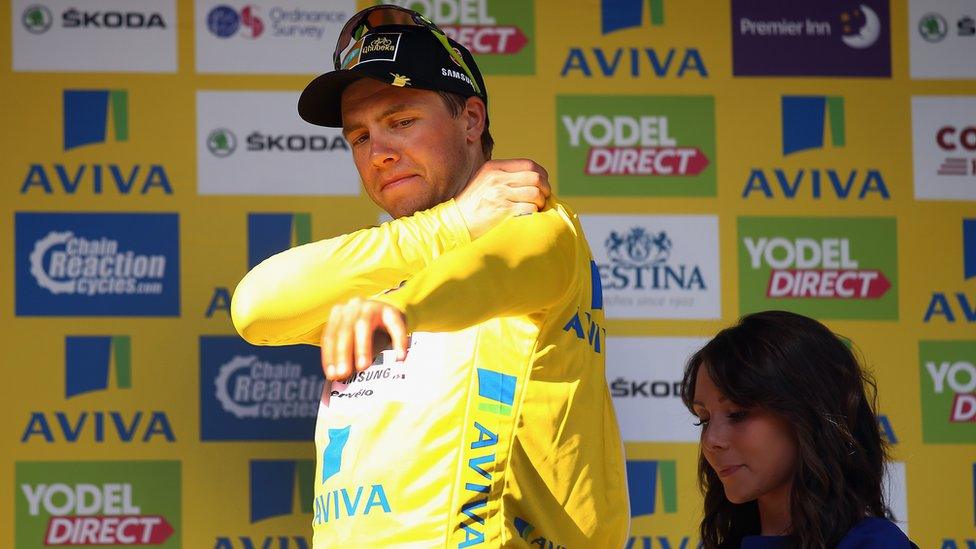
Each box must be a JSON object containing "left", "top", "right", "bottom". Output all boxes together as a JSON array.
[{"left": 694, "top": 365, "right": 797, "bottom": 503}]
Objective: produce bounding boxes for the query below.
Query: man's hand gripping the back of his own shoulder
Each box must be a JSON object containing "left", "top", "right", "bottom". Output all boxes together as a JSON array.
[{"left": 455, "top": 159, "right": 552, "bottom": 240}]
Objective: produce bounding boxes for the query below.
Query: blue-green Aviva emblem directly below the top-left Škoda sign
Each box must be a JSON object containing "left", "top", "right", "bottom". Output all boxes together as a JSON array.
[{"left": 64, "top": 90, "right": 129, "bottom": 151}]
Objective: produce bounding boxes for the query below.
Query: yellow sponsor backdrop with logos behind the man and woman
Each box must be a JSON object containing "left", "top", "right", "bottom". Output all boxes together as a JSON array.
[{"left": 0, "top": 0, "right": 976, "bottom": 549}]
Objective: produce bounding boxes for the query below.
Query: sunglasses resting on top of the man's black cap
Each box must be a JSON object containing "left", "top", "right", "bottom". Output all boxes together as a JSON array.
[{"left": 332, "top": 5, "right": 484, "bottom": 95}]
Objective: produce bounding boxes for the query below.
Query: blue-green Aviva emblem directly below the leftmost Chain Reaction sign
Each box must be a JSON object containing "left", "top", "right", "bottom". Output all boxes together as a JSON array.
[{"left": 64, "top": 336, "right": 132, "bottom": 398}]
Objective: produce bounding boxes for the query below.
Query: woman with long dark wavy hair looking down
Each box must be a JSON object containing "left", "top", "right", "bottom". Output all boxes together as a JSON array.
[{"left": 681, "top": 311, "right": 913, "bottom": 549}]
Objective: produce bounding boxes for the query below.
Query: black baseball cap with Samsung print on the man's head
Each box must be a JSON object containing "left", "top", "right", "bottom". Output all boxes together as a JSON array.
[{"left": 298, "top": 16, "right": 488, "bottom": 128}]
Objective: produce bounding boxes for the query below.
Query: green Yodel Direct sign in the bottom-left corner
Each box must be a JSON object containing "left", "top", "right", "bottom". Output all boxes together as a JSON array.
[{"left": 15, "top": 461, "right": 180, "bottom": 549}]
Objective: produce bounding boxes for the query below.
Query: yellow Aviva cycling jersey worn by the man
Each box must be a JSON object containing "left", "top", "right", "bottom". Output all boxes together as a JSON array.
[{"left": 232, "top": 201, "right": 629, "bottom": 549}]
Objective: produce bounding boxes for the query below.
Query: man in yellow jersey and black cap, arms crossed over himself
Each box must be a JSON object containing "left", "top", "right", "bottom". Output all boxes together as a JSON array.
[{"left": 232, "top": 6, "right": 629, "bottom": 549}]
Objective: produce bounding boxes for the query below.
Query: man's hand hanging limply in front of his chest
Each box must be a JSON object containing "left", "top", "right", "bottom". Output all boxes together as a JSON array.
[{"left": 322, "top": 298, "right": 407, "bottom": 381}]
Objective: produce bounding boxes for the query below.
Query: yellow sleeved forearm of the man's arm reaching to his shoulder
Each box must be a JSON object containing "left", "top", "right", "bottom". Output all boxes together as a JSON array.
[{"left": 231, "top": 200, "right": 470, "bottom": 345}]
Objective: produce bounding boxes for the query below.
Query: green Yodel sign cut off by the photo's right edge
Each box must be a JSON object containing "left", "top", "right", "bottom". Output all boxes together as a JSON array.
[{"left": 918, "top": 341, "right": 976, "bottom": 444}]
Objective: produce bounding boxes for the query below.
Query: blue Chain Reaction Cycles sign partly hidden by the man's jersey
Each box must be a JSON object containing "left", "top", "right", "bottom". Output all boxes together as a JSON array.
[{"left": 200, "top": 336, "right": 324, "bottom": 441}]
